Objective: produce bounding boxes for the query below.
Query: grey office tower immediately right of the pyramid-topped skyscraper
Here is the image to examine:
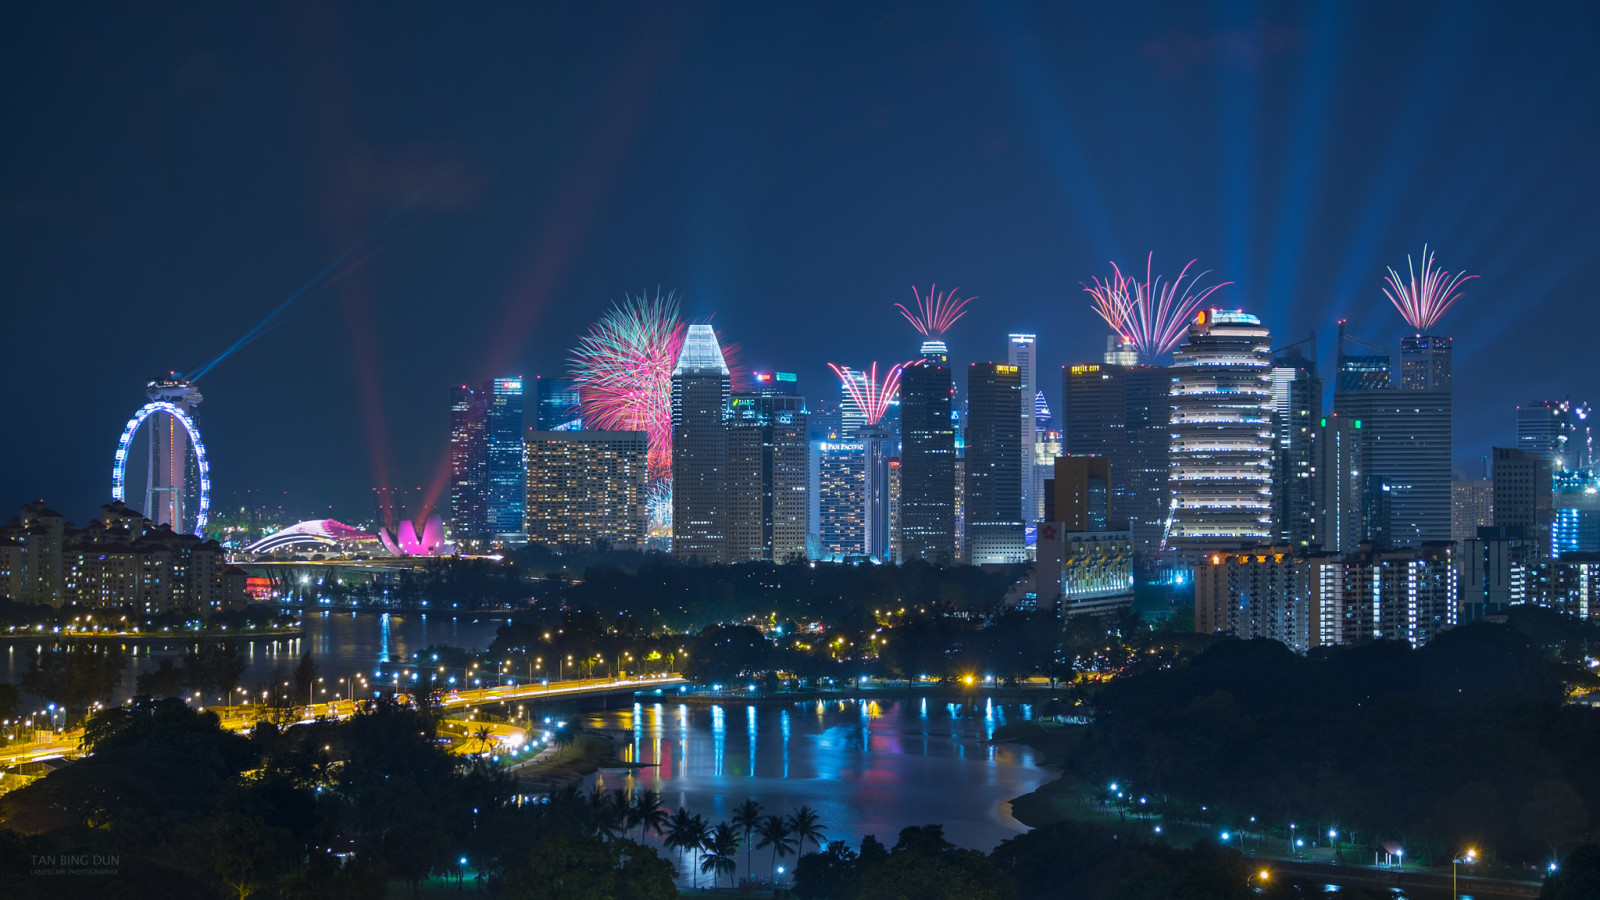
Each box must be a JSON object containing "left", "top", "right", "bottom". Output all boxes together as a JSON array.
[{"left": 728, "top": 384, "right": 811, "bottom": 562}]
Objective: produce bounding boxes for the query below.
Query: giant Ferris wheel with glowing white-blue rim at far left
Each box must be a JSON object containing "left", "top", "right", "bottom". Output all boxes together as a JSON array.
[{"left": 110, "top": 378, "right": 211, "bottom": 536}]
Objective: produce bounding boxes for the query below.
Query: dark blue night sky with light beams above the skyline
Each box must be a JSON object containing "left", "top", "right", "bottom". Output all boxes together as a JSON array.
[{"left": 0, "top": 0, "right": 1600, "bottom": 522}]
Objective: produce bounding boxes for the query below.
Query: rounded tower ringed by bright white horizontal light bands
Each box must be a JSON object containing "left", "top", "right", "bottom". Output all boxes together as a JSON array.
[{"left": 1166, "top": 309, "right": 1272, "bottom": 557}]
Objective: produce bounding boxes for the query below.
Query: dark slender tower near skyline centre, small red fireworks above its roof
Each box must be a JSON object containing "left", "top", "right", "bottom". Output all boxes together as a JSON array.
[{"left": 901, "top": 357, "right": 955, "bottom": 562}]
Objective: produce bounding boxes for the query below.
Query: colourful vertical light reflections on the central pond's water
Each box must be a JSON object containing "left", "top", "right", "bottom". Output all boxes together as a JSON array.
[{"left": 584, "top": 698, "right": 1054, "bottom": 876}]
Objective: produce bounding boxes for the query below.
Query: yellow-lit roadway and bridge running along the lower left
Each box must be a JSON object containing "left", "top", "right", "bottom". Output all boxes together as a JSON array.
[{"left": 0, "top": 674, "right": 688, "bottom": 767}]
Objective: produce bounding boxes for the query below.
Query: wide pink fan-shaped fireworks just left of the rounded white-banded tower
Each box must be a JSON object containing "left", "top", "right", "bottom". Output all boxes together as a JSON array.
[{"left": 1083, "top": 253, "right": 1234, "bottom": 362}]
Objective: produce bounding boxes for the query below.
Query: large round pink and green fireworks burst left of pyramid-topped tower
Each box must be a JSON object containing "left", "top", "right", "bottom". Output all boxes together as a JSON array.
[{"left": 570, "top": 291, "right": 688, "bottom": 482}]
